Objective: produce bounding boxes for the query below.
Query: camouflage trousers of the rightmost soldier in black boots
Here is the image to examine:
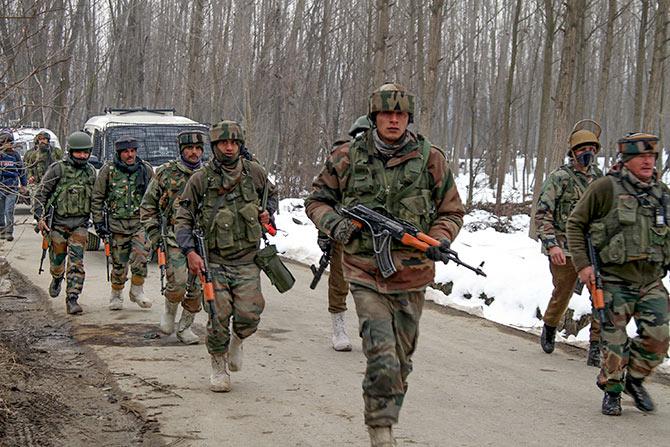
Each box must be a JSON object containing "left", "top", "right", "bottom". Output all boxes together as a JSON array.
[{"left": 598, "top": 280, "right": 669, "bottom": 392}]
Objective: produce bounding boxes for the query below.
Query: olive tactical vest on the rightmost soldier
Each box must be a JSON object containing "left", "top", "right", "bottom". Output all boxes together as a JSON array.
[{"left": 591, "top": 175, "right": 670, "bottom": 265}]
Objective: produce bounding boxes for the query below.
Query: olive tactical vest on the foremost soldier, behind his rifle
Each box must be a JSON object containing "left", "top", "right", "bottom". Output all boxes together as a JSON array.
[{"left": 342, "top": 132, "right": 436, "bottom": 254}]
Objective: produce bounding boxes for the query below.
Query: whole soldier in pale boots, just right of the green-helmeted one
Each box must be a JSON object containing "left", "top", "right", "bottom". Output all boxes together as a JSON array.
[{"left": 91, "top": 137, "right": 153, "bottom": 310}]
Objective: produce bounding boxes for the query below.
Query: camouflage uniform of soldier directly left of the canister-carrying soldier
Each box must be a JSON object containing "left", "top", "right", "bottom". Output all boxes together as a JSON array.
[{"left": 140, "top": 160, "right": 201, "bottom": 313}]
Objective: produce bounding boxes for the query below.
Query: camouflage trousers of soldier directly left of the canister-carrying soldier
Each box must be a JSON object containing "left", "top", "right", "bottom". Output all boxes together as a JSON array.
[{"left": 163, "top": 246, "right": 202, "bottom": 314}]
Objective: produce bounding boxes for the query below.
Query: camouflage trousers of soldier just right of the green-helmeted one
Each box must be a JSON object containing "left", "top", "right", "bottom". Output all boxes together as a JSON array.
[{"left": 110, "top": 227, "right": 149, "bottom": 290}]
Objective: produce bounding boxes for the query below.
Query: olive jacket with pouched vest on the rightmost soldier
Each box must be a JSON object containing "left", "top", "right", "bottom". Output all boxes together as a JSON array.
[{"left": 567, "top": 168, "right": 670, "bottom": 285}]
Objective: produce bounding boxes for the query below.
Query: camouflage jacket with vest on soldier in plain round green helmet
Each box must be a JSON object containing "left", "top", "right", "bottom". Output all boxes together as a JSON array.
[{"left": 33, "top": 159, "right": 96, "bottom": 228}]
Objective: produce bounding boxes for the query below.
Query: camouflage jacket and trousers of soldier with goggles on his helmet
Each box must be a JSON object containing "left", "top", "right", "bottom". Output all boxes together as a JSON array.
[{"left": 535, "top": 162, "right": 603, "bottom": 342}]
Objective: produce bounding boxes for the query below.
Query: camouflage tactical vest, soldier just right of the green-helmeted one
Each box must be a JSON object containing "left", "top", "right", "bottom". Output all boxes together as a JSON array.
[{"left": 106, "top": 162, "right": 146, "bottom": 220}]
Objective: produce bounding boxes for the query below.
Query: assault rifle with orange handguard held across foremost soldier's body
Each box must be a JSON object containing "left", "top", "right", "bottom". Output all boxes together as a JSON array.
[{"left": 341, "top": 204, "right": 486, "bottom": 278}]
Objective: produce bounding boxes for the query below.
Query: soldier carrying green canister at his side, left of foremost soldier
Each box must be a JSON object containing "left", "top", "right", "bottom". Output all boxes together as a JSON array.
[{"left": 175, "top": 121, "right": 277, "bottom": 392}]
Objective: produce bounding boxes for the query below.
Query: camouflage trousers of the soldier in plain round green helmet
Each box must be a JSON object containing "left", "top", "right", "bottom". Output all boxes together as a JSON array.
[{"left": 49, "top": 226, "right": 88, "bottom": 295}]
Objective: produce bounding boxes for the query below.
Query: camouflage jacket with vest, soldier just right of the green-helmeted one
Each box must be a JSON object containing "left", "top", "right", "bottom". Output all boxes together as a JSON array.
[{"left": 91, "top": 161, "right": 154, "bottom": 234}]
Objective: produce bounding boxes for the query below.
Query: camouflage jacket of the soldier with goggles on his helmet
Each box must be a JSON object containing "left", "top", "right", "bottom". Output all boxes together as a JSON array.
[{"left": 535, "top": 163, "right": 603, "bottom": 256}]
